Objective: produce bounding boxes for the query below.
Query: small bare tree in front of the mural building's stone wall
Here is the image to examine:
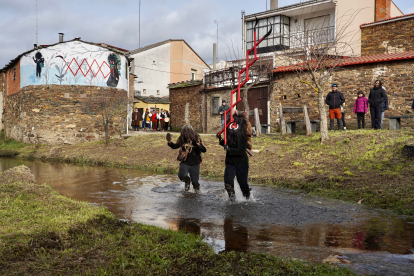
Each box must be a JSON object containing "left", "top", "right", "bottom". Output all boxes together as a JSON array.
[{"left": 81, "top": 91, "right": 128, "bottom": 145}]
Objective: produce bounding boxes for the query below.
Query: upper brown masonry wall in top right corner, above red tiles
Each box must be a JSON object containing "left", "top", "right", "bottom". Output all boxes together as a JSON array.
[{"left": 361, "top": 18, "right": 414, "bottom": 56}]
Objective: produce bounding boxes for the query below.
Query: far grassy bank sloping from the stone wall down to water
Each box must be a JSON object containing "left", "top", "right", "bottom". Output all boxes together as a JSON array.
[{"left": 0, "top": 130, "right": 414, "bottom": 215}]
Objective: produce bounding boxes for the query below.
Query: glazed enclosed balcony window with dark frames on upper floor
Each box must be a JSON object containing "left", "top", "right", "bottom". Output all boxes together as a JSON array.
[{"left": 246, "top": 15, "right": 290, "bottom": 53}]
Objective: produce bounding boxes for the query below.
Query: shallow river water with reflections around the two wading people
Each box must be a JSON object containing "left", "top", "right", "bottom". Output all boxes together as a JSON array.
[{"left": 0, "top": 158, "right": 414, "bottom": 275}]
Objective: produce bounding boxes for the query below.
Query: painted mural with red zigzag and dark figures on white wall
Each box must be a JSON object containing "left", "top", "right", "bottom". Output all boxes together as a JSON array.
[{"left": 20, "top": 41, "right": 128, "bottom": 90}]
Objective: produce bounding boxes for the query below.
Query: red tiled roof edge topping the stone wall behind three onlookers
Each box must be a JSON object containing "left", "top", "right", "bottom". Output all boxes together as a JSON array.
[{"left": 272, "top": 51, "right": 414, "bottom": 73}]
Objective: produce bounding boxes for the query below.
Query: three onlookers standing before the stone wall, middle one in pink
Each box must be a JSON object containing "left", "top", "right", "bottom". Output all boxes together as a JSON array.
[{"left": 325, "top": 80, "right": 414, "bottom": 131}]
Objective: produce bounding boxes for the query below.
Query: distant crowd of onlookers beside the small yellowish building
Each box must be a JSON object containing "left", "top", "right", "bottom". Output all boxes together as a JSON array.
[{"left": 131, "top": 108, "right": 170, "bottom": 131}]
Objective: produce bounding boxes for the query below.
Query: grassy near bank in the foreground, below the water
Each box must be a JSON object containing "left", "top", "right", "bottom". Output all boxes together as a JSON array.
[{"left": 0, "top": 166, "right": 354, "bottom": 275}]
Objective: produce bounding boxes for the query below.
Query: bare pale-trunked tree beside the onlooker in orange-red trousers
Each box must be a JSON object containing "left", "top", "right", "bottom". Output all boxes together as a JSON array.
[{"left": 276, "top": 10, "right": 360, "bottom": 143}]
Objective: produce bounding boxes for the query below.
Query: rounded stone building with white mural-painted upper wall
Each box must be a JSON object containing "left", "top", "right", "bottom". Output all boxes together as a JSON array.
[{"left": 0, "top": 34, "right": 133, "bottom": 144}]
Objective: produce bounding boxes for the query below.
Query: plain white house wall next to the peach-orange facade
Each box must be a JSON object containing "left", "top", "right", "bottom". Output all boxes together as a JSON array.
[{"left": 131, "top": 43, "right": 170, "bottom": 97}]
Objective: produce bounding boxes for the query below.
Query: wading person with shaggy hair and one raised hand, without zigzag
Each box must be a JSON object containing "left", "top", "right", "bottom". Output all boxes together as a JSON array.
[{"left": 167, "top": 125, "right": 207, "bottom": 192}]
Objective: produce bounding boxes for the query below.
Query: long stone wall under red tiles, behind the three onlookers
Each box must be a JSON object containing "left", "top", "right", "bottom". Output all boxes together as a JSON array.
[{"left": 270, "top": 60, "right": 414, "bottom": 131}]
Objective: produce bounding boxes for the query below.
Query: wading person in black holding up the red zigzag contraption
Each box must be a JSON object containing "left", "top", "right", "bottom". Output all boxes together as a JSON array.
[{"left": 218, "top": 115, "right": 250, "bottom": 201}]
